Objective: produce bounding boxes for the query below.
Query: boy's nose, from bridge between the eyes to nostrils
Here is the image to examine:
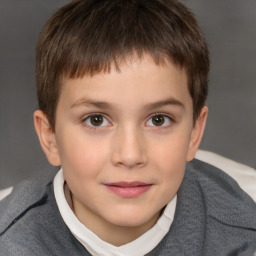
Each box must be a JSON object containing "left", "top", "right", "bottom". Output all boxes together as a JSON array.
[{"left": 112, "top": 127, "right": 147, "bottom": 169}]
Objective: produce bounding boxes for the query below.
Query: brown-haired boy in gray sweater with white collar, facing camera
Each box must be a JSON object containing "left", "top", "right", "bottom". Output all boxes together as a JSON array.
[{"left": 0, "top": 0, "right": 256, "bottom": 256}]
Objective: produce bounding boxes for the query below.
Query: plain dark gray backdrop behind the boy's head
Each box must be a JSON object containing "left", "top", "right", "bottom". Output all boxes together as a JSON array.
[{"left": 0, "top": 0, "right": 256, "bottom": 189}]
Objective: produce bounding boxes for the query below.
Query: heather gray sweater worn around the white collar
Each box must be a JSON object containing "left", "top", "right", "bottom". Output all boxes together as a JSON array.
[{"left": 0, "top": 160, "right": 256, "bottom": 256}]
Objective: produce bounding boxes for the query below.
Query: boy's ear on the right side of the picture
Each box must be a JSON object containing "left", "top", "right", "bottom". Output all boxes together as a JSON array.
[{"left": 187, "top": 106, "right": 208, "bottom": 162}]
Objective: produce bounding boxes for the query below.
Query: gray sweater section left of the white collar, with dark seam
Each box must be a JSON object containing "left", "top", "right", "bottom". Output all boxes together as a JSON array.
[{"left": 0, "top": 169, "right": 89, "bottom": 256}]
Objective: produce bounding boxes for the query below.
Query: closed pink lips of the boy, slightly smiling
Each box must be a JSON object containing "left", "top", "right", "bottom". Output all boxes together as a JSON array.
[{"left": 104, "top": 181, "right": 152, "bottom": 198}]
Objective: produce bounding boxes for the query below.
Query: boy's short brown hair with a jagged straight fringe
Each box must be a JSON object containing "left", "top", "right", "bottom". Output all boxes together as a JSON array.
[{"left": 36, "top": 0, "right": 209, "bottom": 129}]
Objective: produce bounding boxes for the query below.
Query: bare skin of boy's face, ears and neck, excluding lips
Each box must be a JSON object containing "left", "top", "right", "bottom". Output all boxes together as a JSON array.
[{"left": 34, "top": 55, "right": 208, "bottom": 246}]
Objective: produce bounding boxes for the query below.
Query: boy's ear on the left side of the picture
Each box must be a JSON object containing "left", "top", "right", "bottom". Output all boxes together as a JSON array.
[{"left": 34, "top": 110, "right": 60, "bottom": 166}]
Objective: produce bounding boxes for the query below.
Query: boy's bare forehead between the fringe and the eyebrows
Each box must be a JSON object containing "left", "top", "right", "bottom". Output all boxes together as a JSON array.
[{"left": 60, "top": 55, "right": 192, "bottom": 111}]
